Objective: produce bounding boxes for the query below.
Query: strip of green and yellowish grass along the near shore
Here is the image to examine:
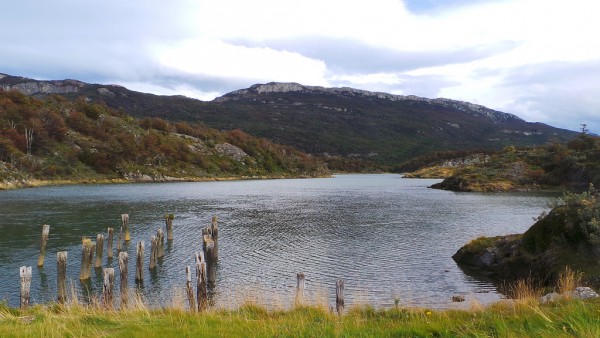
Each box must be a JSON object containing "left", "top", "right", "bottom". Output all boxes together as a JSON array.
[{"left": 0, "top": 300, "right": 600, "bottom": 338}]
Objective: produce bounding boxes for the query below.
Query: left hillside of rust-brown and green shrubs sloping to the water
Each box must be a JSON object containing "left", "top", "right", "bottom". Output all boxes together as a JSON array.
[{"left": 0, "top": 89, "right": 328, "bottom": 188}]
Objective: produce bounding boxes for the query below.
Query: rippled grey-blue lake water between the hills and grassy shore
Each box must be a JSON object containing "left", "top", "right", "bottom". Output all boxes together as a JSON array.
[{"left": 0, "top": 174, "right": 552, "bottom": 308}]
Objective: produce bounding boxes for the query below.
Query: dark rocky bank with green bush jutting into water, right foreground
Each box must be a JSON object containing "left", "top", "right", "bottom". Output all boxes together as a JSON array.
[{"left": 453, "top": 185, "right": 600, "bottom": 286}]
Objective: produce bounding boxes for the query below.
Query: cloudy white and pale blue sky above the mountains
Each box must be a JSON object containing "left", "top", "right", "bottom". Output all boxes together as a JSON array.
[{"left": 0, "top": 0, "right": 600, "bottom": 134}]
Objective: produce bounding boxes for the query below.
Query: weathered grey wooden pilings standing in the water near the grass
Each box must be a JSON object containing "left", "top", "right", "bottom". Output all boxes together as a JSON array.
[{"left": 20, "top": 214, "right": 344, "bottom": 314}]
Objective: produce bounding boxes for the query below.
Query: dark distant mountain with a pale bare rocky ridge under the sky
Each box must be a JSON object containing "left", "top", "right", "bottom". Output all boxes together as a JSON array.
[{"left": 0, "top": 75, "right": 577, "bottom": 165}]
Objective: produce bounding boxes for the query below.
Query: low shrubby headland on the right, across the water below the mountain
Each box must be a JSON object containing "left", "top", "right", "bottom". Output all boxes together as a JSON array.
[{"left": 405, "top": 132, "right": 600, "bottom": 191}]
